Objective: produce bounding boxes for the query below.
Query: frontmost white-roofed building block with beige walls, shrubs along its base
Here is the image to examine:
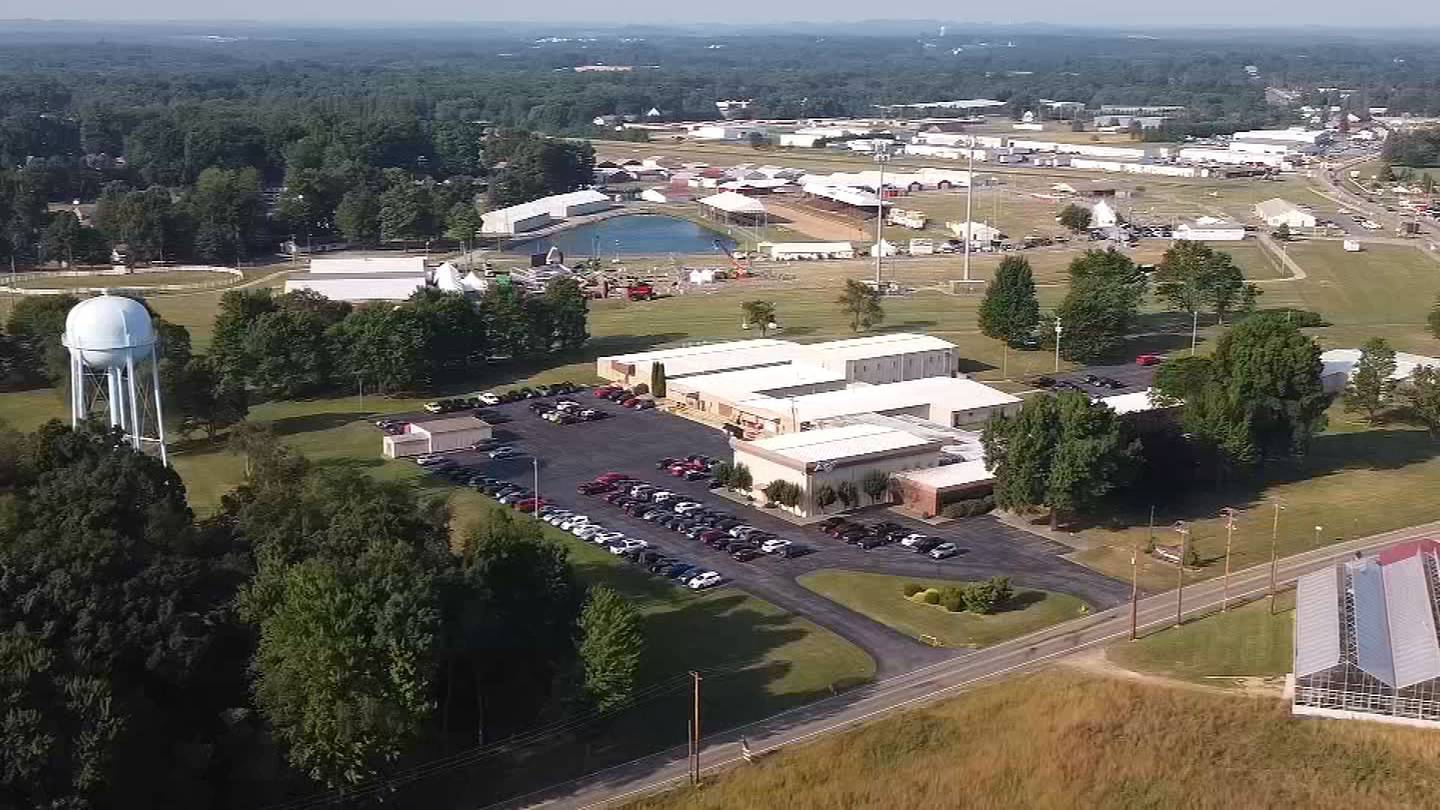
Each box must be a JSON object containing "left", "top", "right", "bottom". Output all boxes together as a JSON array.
[{"left": 730, "top": 424, "right": 945, "bottom": 517}]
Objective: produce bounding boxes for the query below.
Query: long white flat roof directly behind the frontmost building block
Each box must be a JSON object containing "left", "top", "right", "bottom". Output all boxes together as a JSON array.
[{"left": 739, "top": 376, "right": 1020, "bottom": 422}]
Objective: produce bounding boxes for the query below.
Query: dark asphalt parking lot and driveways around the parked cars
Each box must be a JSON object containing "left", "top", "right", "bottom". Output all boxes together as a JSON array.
[{"left": 400, "top": 392, "right": 1129, "bottom": 673}]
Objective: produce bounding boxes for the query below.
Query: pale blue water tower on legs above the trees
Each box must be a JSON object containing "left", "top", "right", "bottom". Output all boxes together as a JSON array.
[{"left": 60, "top": 294, "right": 168, "bottom": 464}]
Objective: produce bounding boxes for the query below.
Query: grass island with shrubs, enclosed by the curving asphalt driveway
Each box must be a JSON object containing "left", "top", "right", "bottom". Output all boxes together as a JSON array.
[{"left": 799, "top": 569, "right": 1086, "bottom": 647}]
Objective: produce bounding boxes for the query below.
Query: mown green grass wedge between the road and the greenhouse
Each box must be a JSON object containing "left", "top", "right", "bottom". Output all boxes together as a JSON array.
[{"left": 1104, "top": 591, "right": 1295, "bottom": 685}]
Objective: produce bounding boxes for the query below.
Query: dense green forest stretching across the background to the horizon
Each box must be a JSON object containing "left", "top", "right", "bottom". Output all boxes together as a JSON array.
[{"left": 0, "top": 23, "right": 1440, "bottom": 264}]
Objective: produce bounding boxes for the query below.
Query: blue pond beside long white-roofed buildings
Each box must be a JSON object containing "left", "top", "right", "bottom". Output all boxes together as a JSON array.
[{"left": 510, "top": 213, "right": 734, "bottom": 259}]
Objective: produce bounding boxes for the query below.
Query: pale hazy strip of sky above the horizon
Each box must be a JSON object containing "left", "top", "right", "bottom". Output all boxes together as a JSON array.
[{"left": 8, "top": 0, "right": 1440, "bottom": 27}]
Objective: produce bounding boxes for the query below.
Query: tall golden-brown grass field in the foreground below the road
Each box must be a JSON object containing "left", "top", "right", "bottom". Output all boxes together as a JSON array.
[{"left": 629, "top": 672, "right": 1440, "bottom": 810}]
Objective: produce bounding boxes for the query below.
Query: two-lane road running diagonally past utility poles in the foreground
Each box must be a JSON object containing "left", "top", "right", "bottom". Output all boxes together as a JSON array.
[{"left": 485, "top": 522, "right": 1440, "bottom": 810}]
